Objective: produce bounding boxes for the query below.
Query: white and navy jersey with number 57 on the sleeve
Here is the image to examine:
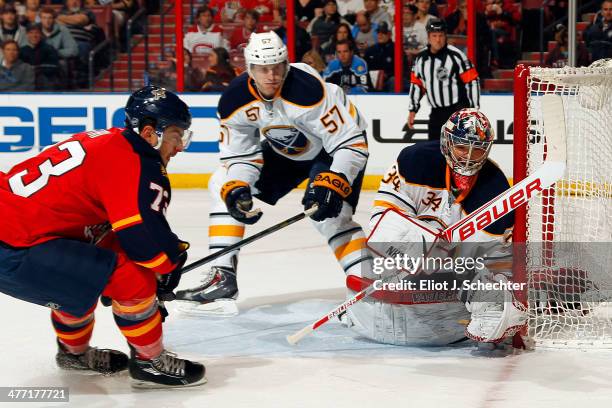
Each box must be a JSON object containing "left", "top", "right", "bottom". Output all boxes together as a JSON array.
[{"left": 218, "top": 64, "right": 368, "bottom": 185}]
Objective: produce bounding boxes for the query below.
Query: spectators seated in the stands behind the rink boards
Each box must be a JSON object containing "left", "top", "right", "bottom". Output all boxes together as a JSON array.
[{"left": 0, "top": 0, "right": 612, "bottom": 93}]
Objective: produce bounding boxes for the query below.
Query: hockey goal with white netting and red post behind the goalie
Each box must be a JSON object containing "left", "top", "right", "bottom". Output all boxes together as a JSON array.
[{"left": 514, "top": 65, "right": 612, "bottom": 348}]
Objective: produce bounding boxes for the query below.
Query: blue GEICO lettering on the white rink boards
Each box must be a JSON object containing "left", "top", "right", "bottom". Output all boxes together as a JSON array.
[{"left": 0, "top": 106, "right": 219, "bottom": 153}]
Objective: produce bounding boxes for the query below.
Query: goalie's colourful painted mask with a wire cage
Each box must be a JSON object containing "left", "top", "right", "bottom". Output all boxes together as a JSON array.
[{"left": 440, "top": 108, "right": 495, "bottom": 176}]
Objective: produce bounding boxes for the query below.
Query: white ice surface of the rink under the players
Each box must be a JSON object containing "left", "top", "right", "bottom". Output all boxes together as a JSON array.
[{"left": 0, "top": 190, "right": 612, "bottom": 408}]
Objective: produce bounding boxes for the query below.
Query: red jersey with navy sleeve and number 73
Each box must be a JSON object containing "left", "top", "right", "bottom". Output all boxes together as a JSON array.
[{"left": 0, "top": 128, "right": 179, "bottom": 273}]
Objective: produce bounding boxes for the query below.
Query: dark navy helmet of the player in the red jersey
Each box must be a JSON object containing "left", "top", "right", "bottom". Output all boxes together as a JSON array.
[{"left": 125, "top": 85, "right": 192, "bottom": 149}]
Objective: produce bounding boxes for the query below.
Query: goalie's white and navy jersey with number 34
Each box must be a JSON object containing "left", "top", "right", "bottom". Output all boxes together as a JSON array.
[{"left": 370, "top": 141, "right": 514, "bottom": 242}]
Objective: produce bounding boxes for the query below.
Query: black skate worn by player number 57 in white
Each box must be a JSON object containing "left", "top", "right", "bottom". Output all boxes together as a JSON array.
[{"left": 176, "top": 266, "right": 238, "bottom": 316}]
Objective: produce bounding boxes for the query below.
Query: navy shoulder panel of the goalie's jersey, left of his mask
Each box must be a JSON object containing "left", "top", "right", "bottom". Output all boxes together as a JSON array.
[{"left": 397, "top": 140, "right": 446, "bottom": 188}]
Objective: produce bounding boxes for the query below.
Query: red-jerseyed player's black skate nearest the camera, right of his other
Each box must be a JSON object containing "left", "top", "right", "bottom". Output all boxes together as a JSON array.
[{"left": 129, "top": 349, "right": 206, "bottom": 388}]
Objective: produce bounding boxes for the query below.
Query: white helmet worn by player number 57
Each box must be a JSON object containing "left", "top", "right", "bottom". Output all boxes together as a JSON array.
[{"left": 244, "top": 31, "right": 289, "bottom": 76}]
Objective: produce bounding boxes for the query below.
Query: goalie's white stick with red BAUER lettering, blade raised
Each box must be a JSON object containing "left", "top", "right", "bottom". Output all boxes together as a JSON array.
[{"left": 287, "top": 95, "right": 567, "bottom": 345}]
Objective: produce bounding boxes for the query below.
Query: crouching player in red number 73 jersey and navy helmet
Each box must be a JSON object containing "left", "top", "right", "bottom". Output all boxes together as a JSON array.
[{"left": 0, "top": 86, "right": 205, "bottom": 387}]
